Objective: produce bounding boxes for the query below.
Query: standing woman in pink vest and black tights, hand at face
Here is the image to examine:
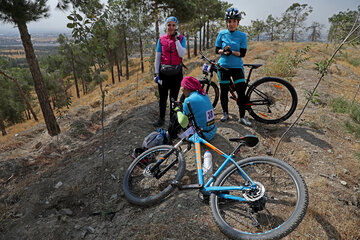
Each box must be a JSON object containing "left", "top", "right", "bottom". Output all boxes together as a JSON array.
[{"left": 153, "top": 17, "right": 186, "bottom": 127}]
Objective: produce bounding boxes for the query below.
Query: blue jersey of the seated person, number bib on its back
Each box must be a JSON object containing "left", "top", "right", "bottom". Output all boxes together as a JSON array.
[{"left": 183, "top": 91, "right": 217, "bottom": 141}]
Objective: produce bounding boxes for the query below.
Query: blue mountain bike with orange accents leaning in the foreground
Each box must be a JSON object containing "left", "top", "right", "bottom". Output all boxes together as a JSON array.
[{"left": 123, "top": 102, "right": 308, "bottom": 239}]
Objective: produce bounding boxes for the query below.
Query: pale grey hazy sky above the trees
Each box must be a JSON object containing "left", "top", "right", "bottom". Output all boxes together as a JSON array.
[{"left": 0, "top": 0, "right": 360, "bottom": 34}]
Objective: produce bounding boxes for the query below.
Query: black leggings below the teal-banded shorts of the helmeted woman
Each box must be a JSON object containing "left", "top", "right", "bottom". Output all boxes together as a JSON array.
[{"left": 220, "top": 82, "right": 246, "bottom": 118}]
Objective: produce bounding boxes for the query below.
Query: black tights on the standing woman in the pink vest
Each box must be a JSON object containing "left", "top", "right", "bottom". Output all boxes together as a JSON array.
[{"left": 158, "top": 72, "right": 183, "bottom": 119}]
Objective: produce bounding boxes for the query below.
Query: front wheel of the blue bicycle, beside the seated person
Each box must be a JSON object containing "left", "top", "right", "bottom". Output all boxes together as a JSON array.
[{"left": 123, "top": 145, "right": 185, "bottom": 206}]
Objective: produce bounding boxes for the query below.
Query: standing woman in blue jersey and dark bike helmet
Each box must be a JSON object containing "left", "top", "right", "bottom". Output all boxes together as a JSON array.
[{"left": 215, "top": 8, "right": 251, "bottom": 126}]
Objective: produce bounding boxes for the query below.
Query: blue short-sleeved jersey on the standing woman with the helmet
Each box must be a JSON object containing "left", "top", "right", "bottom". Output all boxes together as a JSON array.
[{"left": 215, "top": 30, "right": 247, "bottom": 68}]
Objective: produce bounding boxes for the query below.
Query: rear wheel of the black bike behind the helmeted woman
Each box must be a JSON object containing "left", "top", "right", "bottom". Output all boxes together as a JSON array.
[{"left": 246, "top": 77, "right": 298, "bottom": 124}]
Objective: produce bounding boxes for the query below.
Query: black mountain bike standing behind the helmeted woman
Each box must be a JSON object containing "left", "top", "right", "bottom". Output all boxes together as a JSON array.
[{"left": 180, "top": 52, "right": 298, "bottom": 124}]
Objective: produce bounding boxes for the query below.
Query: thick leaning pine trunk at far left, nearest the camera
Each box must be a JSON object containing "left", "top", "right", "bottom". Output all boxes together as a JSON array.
[{"left": 18, "top": 23, "right": 60, "bottom": 136}]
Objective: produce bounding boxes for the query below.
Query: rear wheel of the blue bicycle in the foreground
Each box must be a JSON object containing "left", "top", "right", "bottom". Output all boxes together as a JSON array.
[{"left": 210, "top": 157, "right": 308, "bottom": 240}]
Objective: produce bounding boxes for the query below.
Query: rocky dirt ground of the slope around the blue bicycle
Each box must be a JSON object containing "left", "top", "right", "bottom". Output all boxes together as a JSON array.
[{"left": 0, "top": 42, "right": 360, "bottom": 239}]
